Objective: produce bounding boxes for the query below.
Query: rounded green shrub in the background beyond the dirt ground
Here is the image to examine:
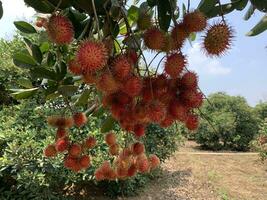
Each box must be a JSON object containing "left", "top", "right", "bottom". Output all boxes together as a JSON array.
[{"left": 195, "top": 93, "right": 258, "bottom": 151}]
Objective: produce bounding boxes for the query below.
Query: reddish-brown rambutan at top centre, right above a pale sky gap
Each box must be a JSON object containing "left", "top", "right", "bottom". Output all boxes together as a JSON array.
[{"left": 144, "top": 27, "right": 165, "bottom": 51}]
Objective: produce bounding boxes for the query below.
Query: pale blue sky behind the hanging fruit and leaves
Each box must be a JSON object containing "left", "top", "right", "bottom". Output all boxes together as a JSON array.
[{"left": 0, "top": 0, "right": 267, "bottom": 105}]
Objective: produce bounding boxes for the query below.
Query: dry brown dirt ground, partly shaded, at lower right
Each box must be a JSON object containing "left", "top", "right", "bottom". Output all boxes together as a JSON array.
[{"left": 71, "top": 142, "right": 267, "bottom": 200}]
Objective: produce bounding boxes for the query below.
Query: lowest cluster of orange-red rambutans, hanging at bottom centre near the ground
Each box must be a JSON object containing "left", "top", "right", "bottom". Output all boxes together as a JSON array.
[{"left": 95, "top": 133, "right": 160, "bottom": 181}]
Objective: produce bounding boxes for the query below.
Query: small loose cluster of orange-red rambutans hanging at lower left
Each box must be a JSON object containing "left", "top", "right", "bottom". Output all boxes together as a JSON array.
[{"left": 44, "top": 112, "right": 96, "bottom": 172}]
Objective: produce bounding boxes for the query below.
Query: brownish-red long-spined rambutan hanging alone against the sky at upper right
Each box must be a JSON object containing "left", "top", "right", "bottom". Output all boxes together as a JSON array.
[{"left": 203, "top": 22, "right": 233, "bottom": 56}]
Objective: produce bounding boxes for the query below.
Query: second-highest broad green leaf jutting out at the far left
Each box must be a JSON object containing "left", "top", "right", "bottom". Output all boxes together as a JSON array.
[{"left": 13, "top": 53, "right": 37, "bottom": 68}]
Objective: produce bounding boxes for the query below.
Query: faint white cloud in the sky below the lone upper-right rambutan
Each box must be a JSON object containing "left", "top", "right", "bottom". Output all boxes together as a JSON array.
[{"left": 187, "top": 43, "right": 232, "bottom": 75}]
